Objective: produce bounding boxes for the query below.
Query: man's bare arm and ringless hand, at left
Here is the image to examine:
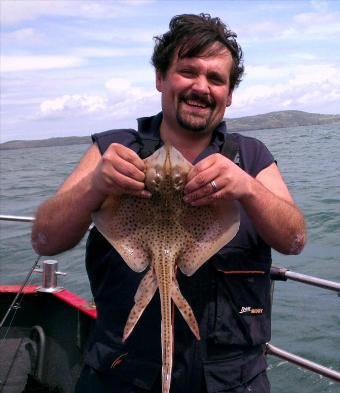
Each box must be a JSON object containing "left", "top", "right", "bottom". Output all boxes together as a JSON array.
[{"left": 32, "top": 144, "right": 150, "bottom": 255}]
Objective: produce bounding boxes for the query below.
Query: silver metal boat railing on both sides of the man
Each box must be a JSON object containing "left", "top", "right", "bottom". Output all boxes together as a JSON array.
[{"left": 0, "top": 215, "right": 340, "bottom": 383}]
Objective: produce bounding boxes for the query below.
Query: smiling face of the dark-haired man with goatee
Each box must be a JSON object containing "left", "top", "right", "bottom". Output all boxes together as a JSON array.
[{"left": 156, "top": 44, "right": 232, "bottom": 133}]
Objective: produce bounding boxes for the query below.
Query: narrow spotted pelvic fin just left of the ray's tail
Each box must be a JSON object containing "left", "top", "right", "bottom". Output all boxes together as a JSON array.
[{"left": 123, "top": 269, "right": 158, "bottom": 341}]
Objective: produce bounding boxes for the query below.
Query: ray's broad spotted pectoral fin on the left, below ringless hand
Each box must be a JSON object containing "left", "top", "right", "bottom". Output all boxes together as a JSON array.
[{"left": 92, "top": 195, "right": 153, "bottom": 272}]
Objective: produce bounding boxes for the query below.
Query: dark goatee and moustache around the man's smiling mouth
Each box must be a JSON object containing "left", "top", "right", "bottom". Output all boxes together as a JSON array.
[{"left": 176, "top": 94, "right": 215, "bottom": 133}]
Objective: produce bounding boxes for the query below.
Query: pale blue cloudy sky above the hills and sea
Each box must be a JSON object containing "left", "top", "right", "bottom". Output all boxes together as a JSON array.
[{"left": 0, "top": 0, "right": 340, "bottom": 142}]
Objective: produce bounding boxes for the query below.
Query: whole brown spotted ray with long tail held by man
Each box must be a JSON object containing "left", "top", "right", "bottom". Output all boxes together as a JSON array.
[{"left": 93, "top": 144, "right": 239, "bottom": 393}]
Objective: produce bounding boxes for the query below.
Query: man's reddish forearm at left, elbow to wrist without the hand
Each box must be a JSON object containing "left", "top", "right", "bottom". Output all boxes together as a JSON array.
[{"left": 32, "top": 177, "right": 103, "bottom": 255}]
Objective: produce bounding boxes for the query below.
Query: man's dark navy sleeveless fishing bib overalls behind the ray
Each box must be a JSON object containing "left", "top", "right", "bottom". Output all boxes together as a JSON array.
[{"left": 85, "top": 118, "right": 271, "bottom": 392}]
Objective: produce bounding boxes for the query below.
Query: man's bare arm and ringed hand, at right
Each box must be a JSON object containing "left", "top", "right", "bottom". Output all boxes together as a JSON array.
[{"left": 184, "top": 154, "right": 307, "bottom": 254}]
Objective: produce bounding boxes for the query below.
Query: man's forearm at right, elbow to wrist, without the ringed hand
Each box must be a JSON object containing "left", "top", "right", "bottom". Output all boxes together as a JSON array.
[{"left": 240, "top": 179, "right": 306, "bottom": 254}]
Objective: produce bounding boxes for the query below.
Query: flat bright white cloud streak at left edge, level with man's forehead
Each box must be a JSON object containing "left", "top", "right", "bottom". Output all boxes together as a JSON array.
[{"left": 1, "top": 56, "right": 84, "bottom": 72}]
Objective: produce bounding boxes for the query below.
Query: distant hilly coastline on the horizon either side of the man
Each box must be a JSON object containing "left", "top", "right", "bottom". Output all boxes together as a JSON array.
[{"left": 0, "top": 111, "right": 340, "bottom": 150}]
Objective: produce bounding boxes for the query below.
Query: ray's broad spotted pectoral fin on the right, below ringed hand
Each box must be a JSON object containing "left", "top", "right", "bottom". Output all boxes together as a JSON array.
[{"left": 177, "top": 200, "right": 240, "bottom": 276}]
